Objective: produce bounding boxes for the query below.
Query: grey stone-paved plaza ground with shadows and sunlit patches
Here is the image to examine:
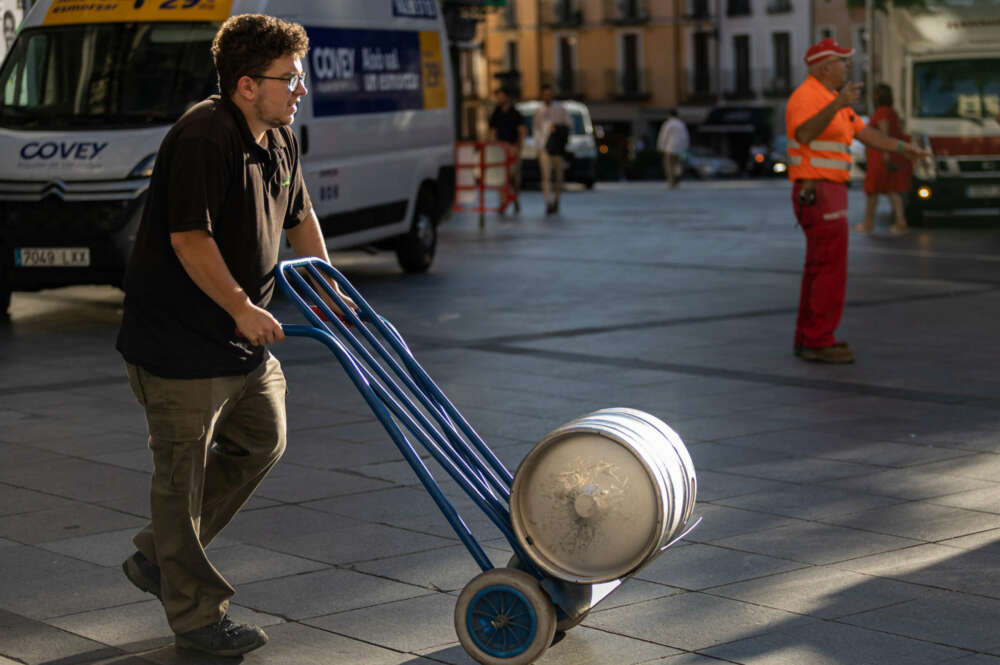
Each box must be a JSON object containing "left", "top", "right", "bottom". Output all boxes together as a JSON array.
[{"left": 0, "top": 181, "right": 1000, "bottom": 665}]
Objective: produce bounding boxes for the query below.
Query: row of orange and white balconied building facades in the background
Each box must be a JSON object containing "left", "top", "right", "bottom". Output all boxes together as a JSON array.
[{"left": 459, "top": 0, "right": 867, "bottom": 170}]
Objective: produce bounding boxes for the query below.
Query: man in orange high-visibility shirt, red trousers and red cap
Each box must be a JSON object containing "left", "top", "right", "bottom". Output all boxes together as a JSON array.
[{"left": 785, "top": 37, "right": 928, "bottom": 363}]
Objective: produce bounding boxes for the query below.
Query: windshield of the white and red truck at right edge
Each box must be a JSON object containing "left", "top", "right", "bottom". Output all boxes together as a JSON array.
[{"left": 913, "top": 58, "right": 1000, "bottom": 120}]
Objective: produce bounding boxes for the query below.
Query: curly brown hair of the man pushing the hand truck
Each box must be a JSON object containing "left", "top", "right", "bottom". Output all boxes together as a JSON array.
[{"left": 212, "top": 14, "right": 309, "bottom": 97}]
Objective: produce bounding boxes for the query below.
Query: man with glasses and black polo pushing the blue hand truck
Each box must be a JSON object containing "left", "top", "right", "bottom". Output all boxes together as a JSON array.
[{"left": 117, "top": 15, "right": 353, "bottom": 656}]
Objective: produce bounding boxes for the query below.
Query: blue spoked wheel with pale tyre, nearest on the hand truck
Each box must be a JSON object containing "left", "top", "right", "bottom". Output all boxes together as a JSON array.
[{"left": 455, "top": 568, "right": 556, "bottom": 665}]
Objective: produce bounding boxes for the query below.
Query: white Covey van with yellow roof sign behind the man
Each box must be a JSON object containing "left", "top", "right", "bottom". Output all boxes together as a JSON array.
[{"left": 0, "top": 0, "right": 455, "bottom": 315}]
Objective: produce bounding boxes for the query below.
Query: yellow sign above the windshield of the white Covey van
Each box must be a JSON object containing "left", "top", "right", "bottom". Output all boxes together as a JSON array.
[{"left": 42, "top": 0, "right": 233, "bottom": 25}]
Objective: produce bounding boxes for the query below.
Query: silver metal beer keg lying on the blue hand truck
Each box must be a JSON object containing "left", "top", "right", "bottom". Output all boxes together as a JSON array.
[{"left": 510, "top": 408, "right": 697, "bottom": 584}]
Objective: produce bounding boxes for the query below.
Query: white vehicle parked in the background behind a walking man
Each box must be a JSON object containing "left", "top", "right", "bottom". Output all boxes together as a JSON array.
[{"left": 517, "top": 101, "right": 597, "bottom": 189}]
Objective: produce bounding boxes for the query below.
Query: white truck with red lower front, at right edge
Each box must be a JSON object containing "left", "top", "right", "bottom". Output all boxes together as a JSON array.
[{"left": 875, "top": 0, "right": 1000, "bottom": 224}]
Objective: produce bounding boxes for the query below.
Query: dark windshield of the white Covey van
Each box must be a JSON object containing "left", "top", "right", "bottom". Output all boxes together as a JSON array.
[{"left": 0, "top": 22, "right": 218, "bottom": 130}]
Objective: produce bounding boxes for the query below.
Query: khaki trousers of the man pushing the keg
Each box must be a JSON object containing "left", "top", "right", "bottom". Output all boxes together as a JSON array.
[{"left": 126, "top": 355, "right": 286, "bottom": 633}]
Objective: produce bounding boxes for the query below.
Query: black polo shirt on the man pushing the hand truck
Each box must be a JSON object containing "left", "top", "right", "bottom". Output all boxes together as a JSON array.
[{"left": 117, "top": 95, "right": 312, "bottom": 379}]
